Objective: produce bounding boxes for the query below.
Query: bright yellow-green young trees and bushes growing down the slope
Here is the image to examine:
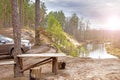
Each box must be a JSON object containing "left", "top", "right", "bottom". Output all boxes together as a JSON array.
[{"left": 47, "top": 14, "right": 78, "bottom": 56}]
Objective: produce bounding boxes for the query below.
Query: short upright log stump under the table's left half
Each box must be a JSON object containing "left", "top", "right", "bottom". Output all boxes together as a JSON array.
[{"left": 29, "top": 67, "right": 42, "bottom": 80}]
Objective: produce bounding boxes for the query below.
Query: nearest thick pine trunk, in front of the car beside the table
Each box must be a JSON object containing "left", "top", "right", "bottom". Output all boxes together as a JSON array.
[{"left": 11, "top": 0, "right": 23, "bottom": 77}]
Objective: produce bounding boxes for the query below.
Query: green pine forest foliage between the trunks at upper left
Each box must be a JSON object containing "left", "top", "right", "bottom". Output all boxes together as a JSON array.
[{"left": 0, "top": 0, "right": 46, "bottom": 28}]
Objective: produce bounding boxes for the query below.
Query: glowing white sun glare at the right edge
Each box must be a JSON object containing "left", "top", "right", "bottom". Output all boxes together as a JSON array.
[{"left": 106, "top": 16, "right": 120, "bottom": 30}]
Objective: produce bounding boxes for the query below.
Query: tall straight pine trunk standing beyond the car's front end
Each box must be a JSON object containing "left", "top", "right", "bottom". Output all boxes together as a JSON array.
[{"left": 35, "top": 0, "right": 40, "bottom": 45}]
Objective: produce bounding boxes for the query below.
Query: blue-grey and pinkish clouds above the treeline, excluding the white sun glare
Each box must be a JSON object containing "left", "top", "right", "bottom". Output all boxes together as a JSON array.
[{"left": 44, "top": 0, "right": 120, "bottom": 29}]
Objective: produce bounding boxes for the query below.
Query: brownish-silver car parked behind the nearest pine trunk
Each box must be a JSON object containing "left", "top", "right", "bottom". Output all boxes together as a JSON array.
[{"left": 0, "top": 35, "right": 31, "bottom": 57}]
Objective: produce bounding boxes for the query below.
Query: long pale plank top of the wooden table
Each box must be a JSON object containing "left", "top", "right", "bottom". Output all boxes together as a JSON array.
[{"left": 17, "top": 53, "right": 66, "bottom": 58}]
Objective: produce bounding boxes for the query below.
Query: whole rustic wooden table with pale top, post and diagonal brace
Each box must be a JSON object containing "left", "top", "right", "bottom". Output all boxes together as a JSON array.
[{"left": 17, "top": 53, "right": 66, "bottom": 74}]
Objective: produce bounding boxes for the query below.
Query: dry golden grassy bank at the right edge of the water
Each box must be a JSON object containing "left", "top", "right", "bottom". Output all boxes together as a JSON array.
[{"left": 105, "top": 44, "right": 120, "bottom": 58}]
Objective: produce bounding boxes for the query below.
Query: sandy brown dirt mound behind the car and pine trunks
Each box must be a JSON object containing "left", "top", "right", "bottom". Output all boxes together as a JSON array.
[{"left": 0, "top": 28, "right": 52, "bottom": 44}]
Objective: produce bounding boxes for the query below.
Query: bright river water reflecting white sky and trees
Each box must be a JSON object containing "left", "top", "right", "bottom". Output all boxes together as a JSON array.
[{"left": 79, "top": 44, "right": 117, "bottom": 59}]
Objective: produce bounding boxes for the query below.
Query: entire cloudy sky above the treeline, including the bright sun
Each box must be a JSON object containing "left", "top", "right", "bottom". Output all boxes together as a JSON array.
[{"left": 41, "top": 0, "right": 120, "bottom": 30}]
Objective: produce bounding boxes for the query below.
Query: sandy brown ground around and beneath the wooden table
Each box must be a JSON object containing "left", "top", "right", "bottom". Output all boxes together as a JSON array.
[{"left": 0, "top": 47, "right": 120, "bottom": 80}]
